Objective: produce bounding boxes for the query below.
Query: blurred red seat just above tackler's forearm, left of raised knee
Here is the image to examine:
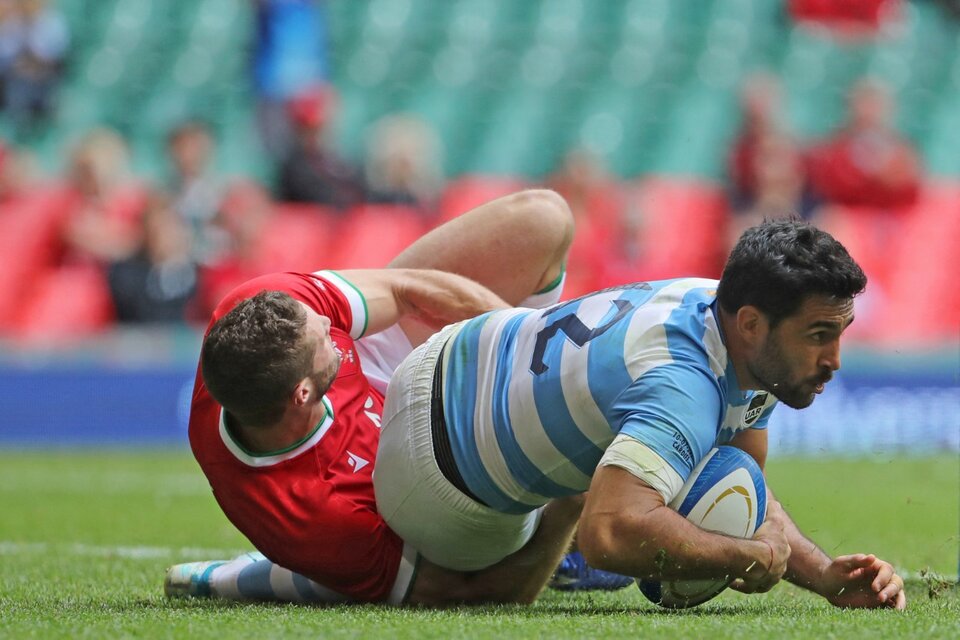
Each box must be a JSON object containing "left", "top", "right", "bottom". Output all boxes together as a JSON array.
[{"left": 331, "top": 205, "right": 428, "bottom": 269}]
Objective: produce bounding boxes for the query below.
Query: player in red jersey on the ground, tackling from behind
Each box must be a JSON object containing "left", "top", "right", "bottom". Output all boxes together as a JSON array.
[{"left": 166, "top": 190, "right": 582, "bottom": 605}]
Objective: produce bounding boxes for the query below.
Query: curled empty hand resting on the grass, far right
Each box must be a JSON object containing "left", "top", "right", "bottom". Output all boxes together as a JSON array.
[{"left": 817, "top": 553, "right": 907, "bottom": 610}]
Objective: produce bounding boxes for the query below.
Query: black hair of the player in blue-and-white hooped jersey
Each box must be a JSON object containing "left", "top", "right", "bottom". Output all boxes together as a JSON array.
[{"left": 717, "top": 218, "right": 867, "bottom": 327}]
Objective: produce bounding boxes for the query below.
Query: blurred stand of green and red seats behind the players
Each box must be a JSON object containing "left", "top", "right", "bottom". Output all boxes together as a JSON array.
[{"left": 0, "top": 0, "right": 960, "bottom": 342}]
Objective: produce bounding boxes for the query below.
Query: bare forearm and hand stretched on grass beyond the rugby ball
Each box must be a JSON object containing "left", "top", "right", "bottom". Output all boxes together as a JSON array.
[{"left": 768, "top": 492, "right": 907, "bottom": 609}]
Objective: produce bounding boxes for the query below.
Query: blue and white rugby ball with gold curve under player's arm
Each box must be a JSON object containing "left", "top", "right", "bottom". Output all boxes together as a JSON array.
[{"left": 637, "top": 447, "right": 767, "bottom": 609}]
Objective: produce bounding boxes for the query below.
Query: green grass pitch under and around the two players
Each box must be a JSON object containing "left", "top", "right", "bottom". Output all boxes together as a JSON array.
[{"left": 0, "top": 451, "right": 960, "bottom": 640}]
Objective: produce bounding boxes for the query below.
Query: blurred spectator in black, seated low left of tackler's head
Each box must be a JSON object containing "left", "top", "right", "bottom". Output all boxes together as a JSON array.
[{"left": 107, "top": 193, "right": 197, "bottom": 323}]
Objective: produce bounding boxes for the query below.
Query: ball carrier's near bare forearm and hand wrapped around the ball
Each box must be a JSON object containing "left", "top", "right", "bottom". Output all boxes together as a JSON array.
[{"left": 577, "top": 466, "right": 790, "bottom": 592}]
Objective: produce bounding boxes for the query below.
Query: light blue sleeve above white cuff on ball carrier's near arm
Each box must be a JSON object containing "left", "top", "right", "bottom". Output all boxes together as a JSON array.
[{"left": 617, "top": 363, "right": 722, "bottom": 480}]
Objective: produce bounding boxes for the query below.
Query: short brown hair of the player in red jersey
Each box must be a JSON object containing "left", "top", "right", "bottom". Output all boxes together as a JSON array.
[{"left": 200, "top": 291, "right": 314, "bottom": 427}]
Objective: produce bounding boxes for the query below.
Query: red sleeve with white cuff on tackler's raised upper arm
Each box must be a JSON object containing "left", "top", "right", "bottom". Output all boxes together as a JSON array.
[{"left": 211, "top": 271, "right": 368, "bottom": 340}]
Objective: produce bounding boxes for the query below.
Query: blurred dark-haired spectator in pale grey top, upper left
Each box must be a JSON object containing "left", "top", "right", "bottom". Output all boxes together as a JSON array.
[{"left": 167, "top": 120, "right": 227, "bottom": 262}]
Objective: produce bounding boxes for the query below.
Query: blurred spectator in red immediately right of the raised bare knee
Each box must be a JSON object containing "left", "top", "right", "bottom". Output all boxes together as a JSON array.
[{"left": 546, "top": 149, "right": 638, "bottom": 298}]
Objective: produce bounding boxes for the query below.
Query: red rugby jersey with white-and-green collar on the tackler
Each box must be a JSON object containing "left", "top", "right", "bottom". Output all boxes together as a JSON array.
[{"left": 190, "top": 271, "right": 416, "bottom": 603}]
